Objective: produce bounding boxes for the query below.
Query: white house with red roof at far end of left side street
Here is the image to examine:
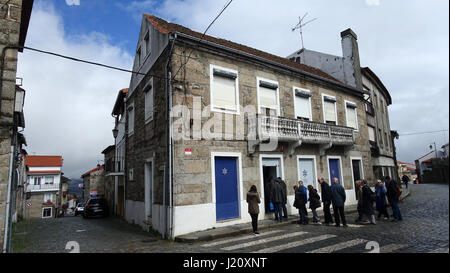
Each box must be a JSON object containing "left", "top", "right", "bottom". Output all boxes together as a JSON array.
[{"left": 25, "top": 155, "right": 63, "bottom": 218}]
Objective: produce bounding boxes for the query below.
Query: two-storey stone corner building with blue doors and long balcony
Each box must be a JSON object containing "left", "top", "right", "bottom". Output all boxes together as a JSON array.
[{"left": 116, "top": 14, "right": 373, "bottom": 237}]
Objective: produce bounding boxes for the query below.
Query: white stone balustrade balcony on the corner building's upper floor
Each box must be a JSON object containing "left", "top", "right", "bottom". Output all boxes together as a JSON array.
[{"left": 249, "top": 116, "right": 355, "bottom": 155}]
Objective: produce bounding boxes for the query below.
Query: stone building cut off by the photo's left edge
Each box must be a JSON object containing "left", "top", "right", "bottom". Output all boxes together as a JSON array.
[{"left": 0, "top": 0, "right": 33, "bottom": 252}]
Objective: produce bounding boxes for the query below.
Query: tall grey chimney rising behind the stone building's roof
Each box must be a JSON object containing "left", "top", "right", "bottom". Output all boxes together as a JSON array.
[{"left": 341, "top": 28, "right": 362, "bottom": 89}]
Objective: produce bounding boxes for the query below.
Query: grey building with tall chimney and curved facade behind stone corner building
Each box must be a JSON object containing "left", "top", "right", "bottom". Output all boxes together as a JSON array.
[{"left": 287, "top": 29, "right": 399, "bottom": 183}]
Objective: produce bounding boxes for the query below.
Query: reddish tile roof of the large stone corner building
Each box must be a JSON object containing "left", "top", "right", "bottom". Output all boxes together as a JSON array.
[{"left": 144, "top": 14, "right": 342, "bottom": 84}]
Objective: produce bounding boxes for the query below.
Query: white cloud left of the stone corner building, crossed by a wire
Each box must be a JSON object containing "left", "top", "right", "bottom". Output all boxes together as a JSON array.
[{"left": 17, "top": 5, "right": 133, "bottom": 178}]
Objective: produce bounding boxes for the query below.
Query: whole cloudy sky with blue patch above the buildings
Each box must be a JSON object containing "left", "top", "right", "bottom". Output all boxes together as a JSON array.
[{"left": 17, "top": 0, "right": 449, "bottom": 178}]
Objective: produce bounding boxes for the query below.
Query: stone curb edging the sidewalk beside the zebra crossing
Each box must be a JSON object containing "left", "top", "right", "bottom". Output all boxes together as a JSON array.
[{"left": 175, "top": 208, "right": 357, "bottom": 243}]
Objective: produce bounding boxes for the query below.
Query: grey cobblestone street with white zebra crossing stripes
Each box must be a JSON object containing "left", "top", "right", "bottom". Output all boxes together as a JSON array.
[{"left": 13, "top": 184, "right": 449, "bottom": 253}]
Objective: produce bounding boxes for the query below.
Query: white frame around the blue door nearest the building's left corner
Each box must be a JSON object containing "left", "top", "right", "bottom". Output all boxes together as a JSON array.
[{"left": 210, "top": 152, "right": 245, "bottom": 223}]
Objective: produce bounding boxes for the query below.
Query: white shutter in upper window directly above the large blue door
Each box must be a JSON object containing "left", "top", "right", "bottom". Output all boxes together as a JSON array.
[{"left": 213, "top": 75, "right": 237, "bottom": 110}]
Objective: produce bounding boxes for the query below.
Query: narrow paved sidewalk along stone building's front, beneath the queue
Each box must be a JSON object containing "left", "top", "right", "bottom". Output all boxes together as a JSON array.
[{"left": 175, "top": 188, "right": 410, "bottom": 243}]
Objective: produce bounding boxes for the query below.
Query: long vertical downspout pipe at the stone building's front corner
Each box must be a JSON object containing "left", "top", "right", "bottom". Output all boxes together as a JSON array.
[{"left": 163, "top": 34, "right": 177, "bottom": 238}]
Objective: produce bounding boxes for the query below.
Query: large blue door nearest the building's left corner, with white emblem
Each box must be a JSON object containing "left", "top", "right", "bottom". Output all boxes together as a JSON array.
[{"left": 214, "top": 157, "right": 239, "bottom": 220}]
